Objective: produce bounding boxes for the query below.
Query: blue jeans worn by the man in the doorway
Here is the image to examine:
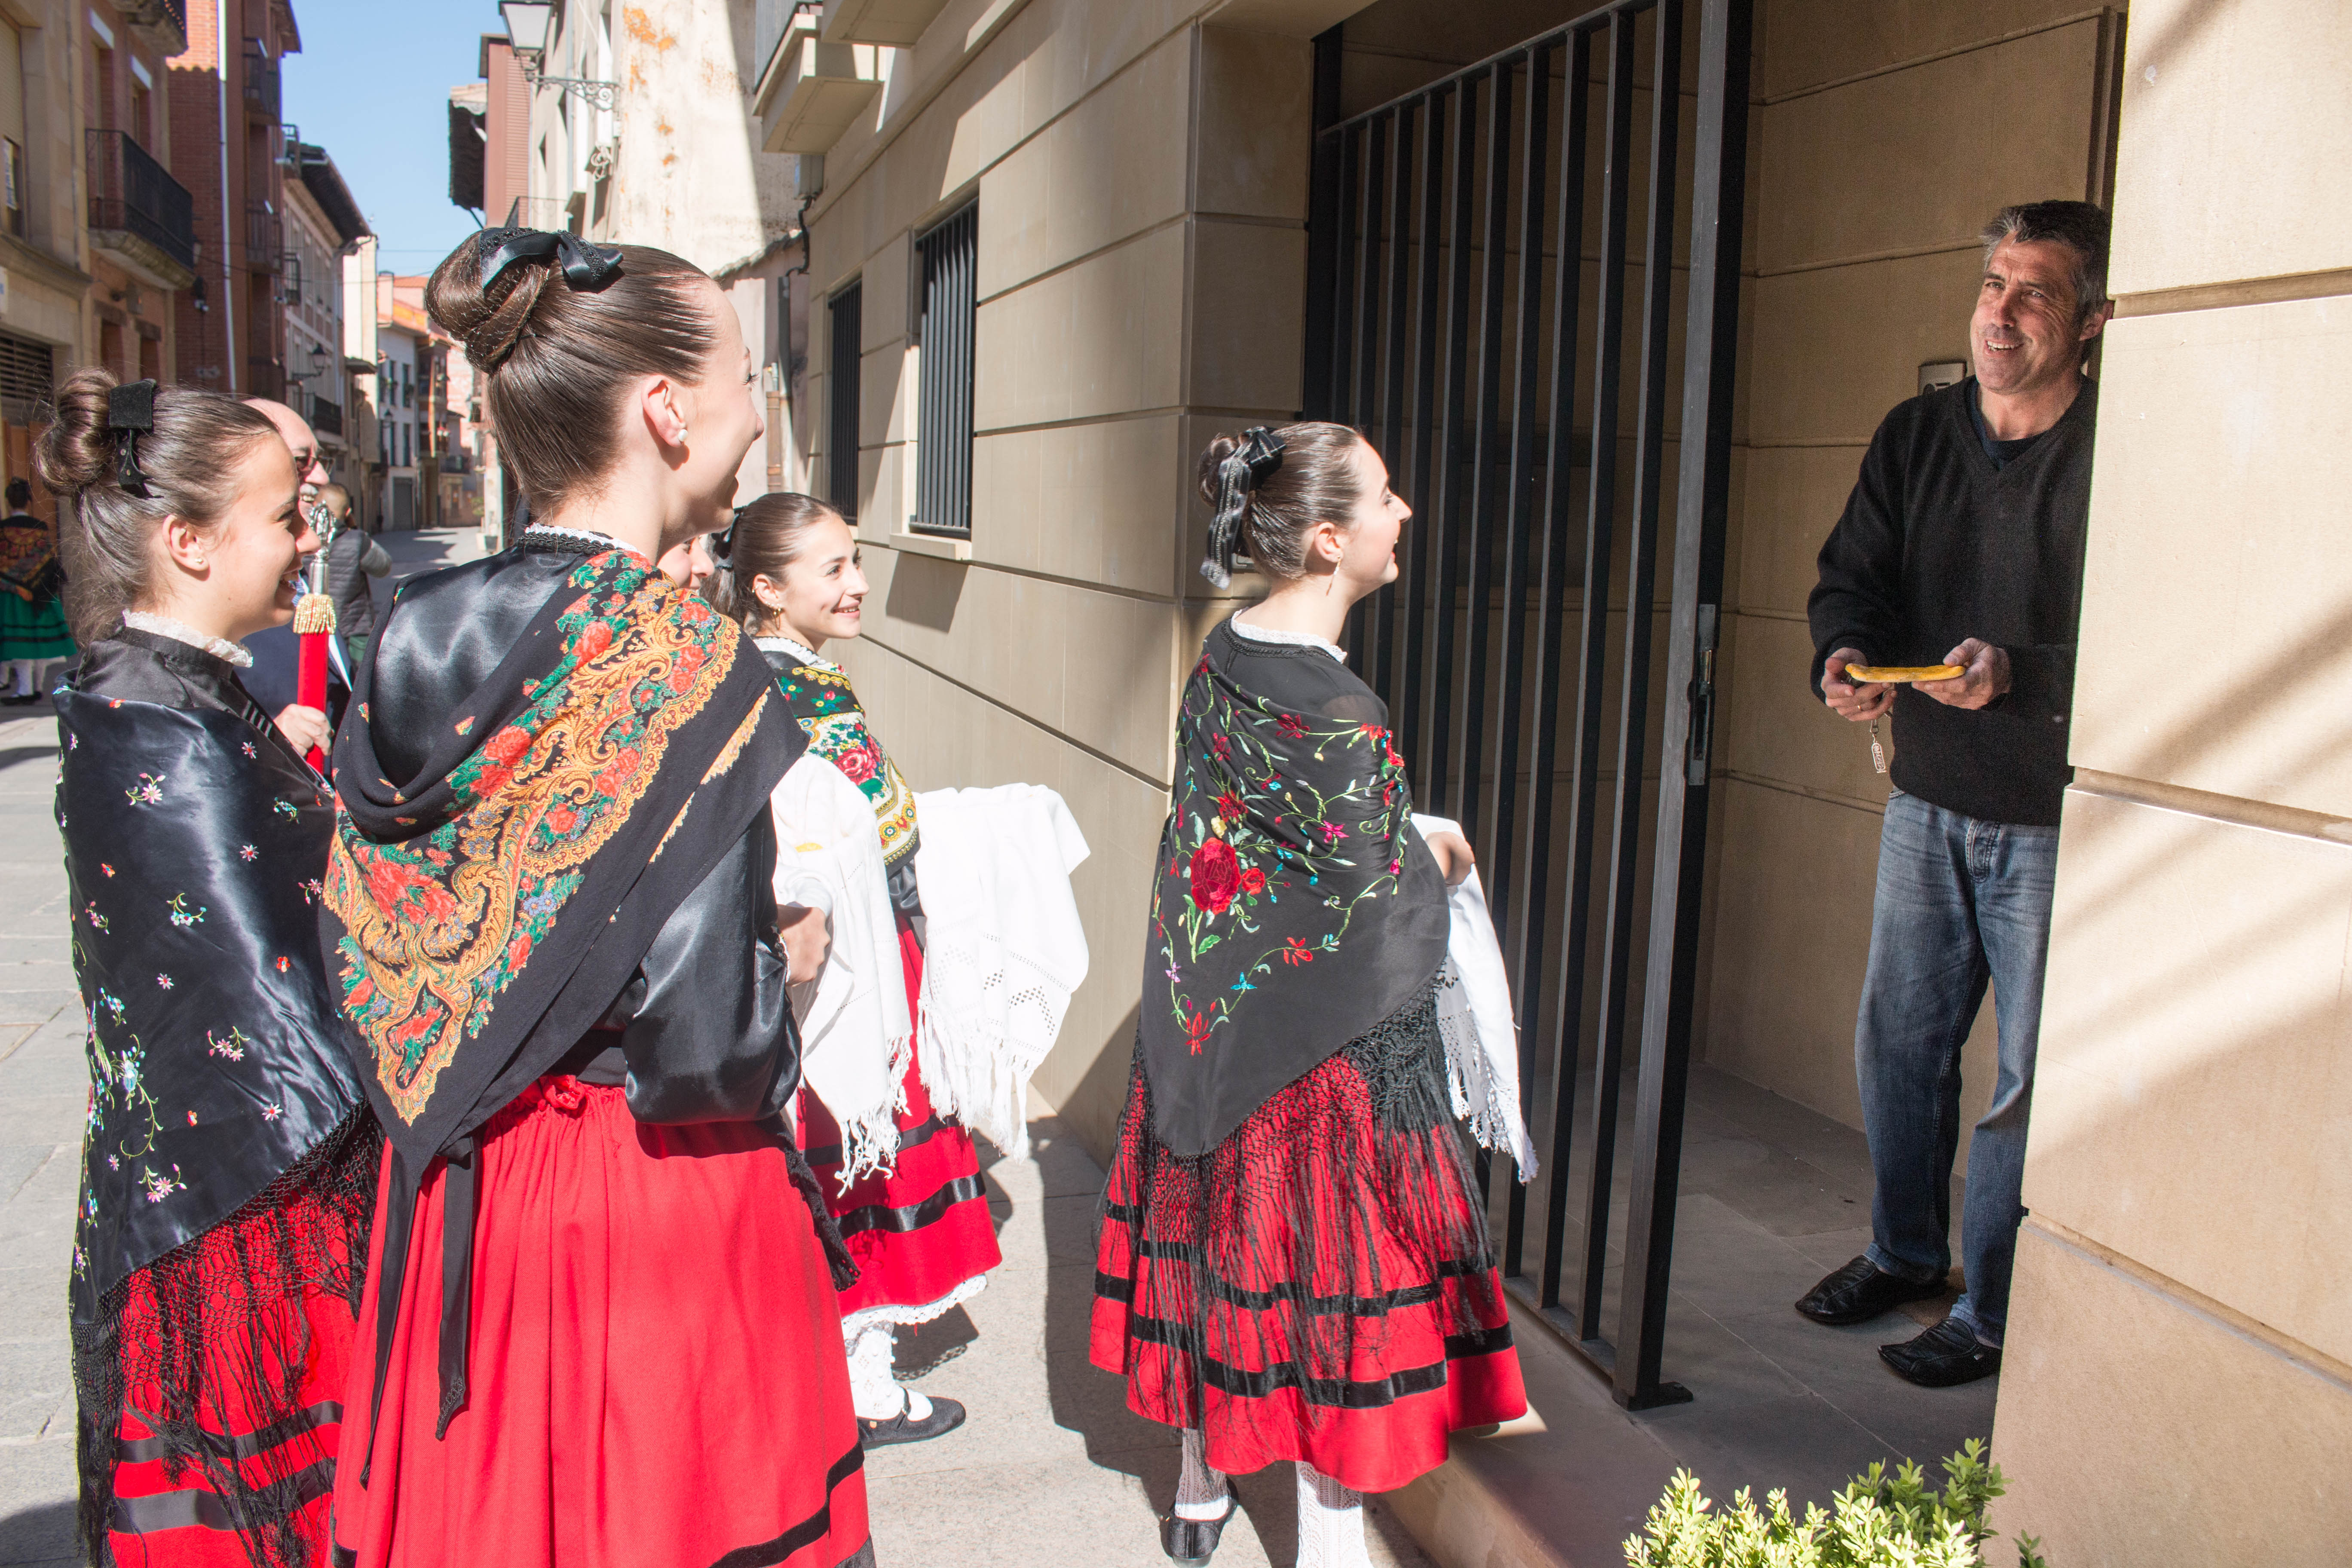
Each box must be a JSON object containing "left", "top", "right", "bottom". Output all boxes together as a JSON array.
[{"left": 1853, "top": 790, "right": 2058, "bottom": 1344}]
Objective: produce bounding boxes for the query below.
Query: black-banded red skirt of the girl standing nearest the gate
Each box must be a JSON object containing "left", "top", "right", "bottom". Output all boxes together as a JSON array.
[{"left": 1089, "top": 1053, "right": 1526, "bottom": 1493}]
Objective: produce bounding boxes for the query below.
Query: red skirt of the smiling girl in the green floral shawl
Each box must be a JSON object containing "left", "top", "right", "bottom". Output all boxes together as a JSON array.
[{"left": 799, "top": 928, "right": 1004, "bottom": 1323}]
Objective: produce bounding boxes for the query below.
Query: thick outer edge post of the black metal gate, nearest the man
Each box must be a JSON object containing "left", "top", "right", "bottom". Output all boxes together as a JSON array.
[{"left": 1614, "top": 0, "right": 1752, "bottom": 1411}]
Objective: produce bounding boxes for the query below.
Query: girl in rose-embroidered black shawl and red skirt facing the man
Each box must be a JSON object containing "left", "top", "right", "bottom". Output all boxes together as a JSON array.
[{"left": 1091, "top": 423, "right": 1526, "bottom": 1568}]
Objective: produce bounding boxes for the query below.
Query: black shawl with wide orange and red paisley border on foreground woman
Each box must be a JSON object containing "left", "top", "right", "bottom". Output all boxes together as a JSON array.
[{"left": 320, "top": 548, "right": 797, "bottom": 1182}]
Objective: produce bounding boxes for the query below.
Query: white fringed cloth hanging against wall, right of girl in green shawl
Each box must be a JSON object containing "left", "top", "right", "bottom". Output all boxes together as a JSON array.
[{"left": 915, "top": 785, "right": 1089, "bottom": 1159}]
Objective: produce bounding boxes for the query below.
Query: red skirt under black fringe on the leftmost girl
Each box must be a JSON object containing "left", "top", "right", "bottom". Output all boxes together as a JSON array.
[{"left": 106, "top": 1128, "right": 377, "bottom": 1568}]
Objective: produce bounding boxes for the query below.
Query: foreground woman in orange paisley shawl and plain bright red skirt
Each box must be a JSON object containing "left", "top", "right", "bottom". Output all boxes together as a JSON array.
[{"left": 322, "top": 228, "right": 873, "bottom": 1568}]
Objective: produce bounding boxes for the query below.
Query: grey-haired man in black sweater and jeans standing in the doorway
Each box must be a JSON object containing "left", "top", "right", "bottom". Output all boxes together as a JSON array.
[{"left": 1797, "top": 202, "right": 2114, "bottom": 1387}]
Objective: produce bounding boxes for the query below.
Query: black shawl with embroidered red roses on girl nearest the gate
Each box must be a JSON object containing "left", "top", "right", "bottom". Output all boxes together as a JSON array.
[{"left": 1141, "top": 625, "right": 1446, "bottom": 1159}]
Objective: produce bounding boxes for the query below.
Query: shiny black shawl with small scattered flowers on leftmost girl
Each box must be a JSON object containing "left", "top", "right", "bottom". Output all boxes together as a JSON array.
[{"left": 54, "top": 630, "right": 362, "bottom": 1323}]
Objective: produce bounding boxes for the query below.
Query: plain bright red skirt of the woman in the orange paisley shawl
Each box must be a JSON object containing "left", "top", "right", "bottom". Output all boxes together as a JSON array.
[{"left": 334, "top": 1077, "right": 868, "bottom": 1568}]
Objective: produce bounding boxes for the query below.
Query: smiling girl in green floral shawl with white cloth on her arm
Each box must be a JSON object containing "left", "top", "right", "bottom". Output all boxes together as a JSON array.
[{"left": 727, "top": 494, "right": 1004, "bottom": 1448}]
